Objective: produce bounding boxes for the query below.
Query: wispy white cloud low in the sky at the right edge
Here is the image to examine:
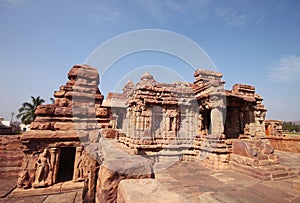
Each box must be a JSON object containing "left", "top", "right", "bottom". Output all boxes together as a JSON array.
[{"left": 269, "top": 55, "right": 300, "bottom": 83}]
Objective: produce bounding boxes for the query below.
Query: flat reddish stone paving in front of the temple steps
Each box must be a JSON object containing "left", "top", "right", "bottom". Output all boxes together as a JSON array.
[{"left": 155, "top": 162, "right": 300, "bottom": 203}]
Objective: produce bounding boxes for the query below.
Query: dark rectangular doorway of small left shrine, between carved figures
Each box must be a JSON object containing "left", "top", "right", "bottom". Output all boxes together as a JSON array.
[{"left": 57, "top": 147, "right": 76, "bottom": 182}]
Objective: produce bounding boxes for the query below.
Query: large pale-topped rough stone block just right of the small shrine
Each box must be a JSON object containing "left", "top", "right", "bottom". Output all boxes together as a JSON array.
[{"left": 96, "top": 139, "right": 153, "bottom": 203}]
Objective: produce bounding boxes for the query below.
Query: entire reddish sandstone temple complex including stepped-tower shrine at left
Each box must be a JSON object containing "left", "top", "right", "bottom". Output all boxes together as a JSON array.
[{"left": 11, "top": 65, "right": 294, "bottom": 202}]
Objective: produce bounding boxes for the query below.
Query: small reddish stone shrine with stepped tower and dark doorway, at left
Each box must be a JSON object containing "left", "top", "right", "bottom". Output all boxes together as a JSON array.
[{"left": 18, "top": 65, "right": 110, "bottom": 201}]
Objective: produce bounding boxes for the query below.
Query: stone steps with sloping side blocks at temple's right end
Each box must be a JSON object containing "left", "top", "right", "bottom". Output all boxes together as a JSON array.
[{"left": 230, "top": 140, "right": 299, "bottom": 181}]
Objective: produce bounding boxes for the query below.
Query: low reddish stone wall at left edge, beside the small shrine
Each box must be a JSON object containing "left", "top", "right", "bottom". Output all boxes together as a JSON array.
[{"left": 0, "top": 135, "right": 24, "bottom": 177}]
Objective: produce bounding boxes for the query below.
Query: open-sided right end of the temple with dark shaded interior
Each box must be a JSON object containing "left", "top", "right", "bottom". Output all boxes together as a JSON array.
[{"left": 225, "top": 84, "right": 267, "bottom": 138}]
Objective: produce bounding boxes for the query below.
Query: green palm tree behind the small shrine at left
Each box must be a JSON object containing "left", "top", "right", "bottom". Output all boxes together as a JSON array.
[{"left": 17, "top": 96, "right": 45, "bottom": 125}]
